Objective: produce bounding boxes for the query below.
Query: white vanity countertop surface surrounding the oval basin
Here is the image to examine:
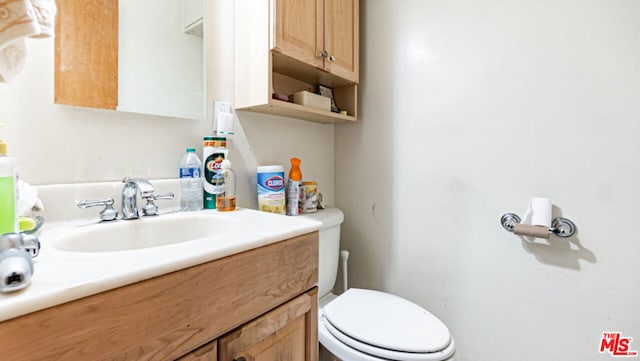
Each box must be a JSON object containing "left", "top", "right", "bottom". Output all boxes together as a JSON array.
[{"left": 0, "top": 209, "right": 320, "bottom": 321}]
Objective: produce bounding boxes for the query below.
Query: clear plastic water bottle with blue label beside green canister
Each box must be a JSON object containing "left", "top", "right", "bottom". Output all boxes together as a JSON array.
[{"left": 180, "top": 148, "right": 203, "bottom": 211}]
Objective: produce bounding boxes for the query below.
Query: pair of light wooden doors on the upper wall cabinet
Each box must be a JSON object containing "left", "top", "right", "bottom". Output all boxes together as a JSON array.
[{"left": 272, "top": 0, "right": 359, "bottom": 83}]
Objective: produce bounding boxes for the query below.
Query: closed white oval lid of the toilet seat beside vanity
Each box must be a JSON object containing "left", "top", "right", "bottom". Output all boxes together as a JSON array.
[{"left": 323, "top": 288, "right": 451, "bottom": 353}]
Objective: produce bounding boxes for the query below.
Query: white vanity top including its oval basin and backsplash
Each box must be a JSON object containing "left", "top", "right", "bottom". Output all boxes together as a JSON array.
[{"left": 0, "top": 179, "right": 320, "bottom": 324}]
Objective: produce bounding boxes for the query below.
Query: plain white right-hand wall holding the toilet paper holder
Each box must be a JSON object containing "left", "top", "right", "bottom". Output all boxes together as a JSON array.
[{"left": 335, "top": 0, "right": 640, "bottom": 361}]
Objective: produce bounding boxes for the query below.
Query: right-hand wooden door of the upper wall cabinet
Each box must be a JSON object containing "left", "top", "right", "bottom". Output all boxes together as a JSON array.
[{"left": 324, "top": 0, "right": 360, "bottom": 83}]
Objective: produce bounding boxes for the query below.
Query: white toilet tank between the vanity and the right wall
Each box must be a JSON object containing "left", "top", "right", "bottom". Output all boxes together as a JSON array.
[{"left": 299, "top": 208, "right": 344, "bottom": 298}]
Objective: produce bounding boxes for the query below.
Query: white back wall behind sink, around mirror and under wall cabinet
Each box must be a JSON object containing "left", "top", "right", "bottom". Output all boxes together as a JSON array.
[{"left": 0, "top": 0, "right": 334, "bottom": 208}]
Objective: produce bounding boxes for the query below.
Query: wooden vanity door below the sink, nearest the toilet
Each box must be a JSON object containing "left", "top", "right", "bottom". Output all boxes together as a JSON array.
[{"left": 218, "top": 289, "right": 318, "bottom": 361}]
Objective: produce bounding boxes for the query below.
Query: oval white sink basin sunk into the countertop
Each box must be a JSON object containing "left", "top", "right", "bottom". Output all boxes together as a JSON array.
[{"left": 50, "top": 213, "right": 234, "bottom": 252}]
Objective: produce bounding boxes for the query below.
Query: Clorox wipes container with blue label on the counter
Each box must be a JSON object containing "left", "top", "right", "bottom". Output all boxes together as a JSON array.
[{"left": 258, "top": 165, "right": 285, "bottom": 214}]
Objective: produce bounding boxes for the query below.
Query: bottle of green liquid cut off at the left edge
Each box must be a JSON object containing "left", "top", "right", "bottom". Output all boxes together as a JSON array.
[{"left": 0, "top": 124, "right": 18, "bottom": 235}]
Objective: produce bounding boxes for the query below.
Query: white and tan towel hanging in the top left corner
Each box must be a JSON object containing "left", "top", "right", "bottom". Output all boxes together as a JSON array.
[{"left": 0, "top": 0, "right": 56, "bottom": 82}]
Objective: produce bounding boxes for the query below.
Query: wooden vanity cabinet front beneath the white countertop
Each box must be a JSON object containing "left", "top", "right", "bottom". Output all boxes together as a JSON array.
[{"left": 0, "top": 232, "right": 318, "bottom": 361}]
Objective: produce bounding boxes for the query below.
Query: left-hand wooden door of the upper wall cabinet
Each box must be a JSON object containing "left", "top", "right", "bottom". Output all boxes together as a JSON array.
[{"left": 272, "top": 0, "right": 324, "bottom": 68}]
